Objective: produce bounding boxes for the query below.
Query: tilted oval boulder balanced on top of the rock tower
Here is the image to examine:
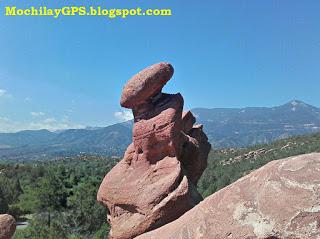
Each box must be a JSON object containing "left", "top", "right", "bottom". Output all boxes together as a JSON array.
[{"left": 120, "top": 62, "right": 173, "bottom": 109}]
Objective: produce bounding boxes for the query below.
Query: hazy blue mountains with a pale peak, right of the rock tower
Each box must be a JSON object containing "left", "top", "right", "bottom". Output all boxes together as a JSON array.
[{"left": 192, "top": 100, "right": 320, "bottom": 148}]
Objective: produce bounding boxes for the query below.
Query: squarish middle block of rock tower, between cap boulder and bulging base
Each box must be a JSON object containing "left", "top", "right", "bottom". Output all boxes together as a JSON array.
[{"left": 133, "top": 94, "right": 183, "bottom": 163}]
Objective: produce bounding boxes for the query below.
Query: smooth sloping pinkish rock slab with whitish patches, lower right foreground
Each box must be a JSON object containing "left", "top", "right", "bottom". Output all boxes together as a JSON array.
[{"left": 137, "top": 153, "right": 320, "bottom": 239}]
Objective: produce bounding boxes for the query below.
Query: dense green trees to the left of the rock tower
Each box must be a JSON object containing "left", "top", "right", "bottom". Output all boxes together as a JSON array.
[{"left": 0, "top": 157, "right": 116, "bottom": 239}]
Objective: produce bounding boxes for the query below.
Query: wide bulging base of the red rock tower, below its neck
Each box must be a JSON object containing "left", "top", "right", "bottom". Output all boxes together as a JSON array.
[{"left": 98, "top": 157, "right": 200, "bottom": 238}]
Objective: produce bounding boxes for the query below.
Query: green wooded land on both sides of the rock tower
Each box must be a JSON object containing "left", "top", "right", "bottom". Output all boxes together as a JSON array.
[{"left": 0, "top": 133, "right": 320, "bottom": 239}]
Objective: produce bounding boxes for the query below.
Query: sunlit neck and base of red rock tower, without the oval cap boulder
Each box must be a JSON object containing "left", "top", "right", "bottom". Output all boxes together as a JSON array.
[{"left": 98, "top": 94, "right": 201, "bottom": 238}]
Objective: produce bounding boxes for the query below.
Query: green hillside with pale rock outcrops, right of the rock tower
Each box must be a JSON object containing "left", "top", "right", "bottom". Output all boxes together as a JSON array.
[{"left": 198, "top": 133, "right": 320, "bottom": 197}]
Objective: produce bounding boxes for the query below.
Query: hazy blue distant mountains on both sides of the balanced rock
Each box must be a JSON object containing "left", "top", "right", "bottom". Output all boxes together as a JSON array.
[{"left": 0, "top": 100, "right": 320, "bottom": 160}]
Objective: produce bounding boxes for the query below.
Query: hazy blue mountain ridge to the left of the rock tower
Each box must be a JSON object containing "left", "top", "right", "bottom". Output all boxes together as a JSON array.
[{"left": 0, "top": 121, "right": 132, "bottom": 160}]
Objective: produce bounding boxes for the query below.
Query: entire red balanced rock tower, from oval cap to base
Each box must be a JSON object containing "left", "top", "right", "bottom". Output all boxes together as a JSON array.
[{"left": 97, "top": 63, "right": 211, "bottom": 239}]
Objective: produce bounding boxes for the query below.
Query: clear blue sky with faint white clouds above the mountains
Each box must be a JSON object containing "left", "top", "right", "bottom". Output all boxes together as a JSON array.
[{"left": 0, "top": 0, "right": 320, "bottom": 132}]
